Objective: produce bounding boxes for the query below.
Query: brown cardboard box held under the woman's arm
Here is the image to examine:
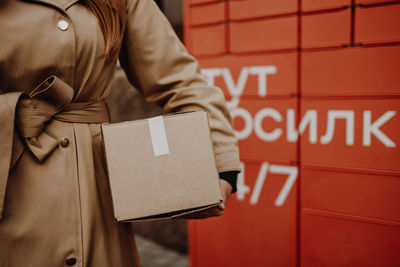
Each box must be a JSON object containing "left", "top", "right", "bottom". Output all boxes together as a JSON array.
[{"left": 102, "top": 111, "right": 223, "bottom": 221}]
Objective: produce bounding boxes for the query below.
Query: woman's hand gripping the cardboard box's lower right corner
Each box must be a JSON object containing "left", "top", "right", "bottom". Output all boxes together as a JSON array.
[{"left": 176, "top": 179, "right": 232, "bottom": 219}]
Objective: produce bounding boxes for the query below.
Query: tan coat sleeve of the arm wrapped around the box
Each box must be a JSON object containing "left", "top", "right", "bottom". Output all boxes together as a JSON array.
[{"left": 120, "top": 0, "right": 240, "bottom": 172}]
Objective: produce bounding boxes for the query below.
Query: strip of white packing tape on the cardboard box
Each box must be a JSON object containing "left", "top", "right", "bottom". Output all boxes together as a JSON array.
[{"left": 147, "top": 116, "right": 169, "bottom": 157}]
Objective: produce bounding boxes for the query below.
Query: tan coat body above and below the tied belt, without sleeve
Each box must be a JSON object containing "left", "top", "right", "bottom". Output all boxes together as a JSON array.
[{"left": 0, "top": 0, "right": 139, "bottom": 267}]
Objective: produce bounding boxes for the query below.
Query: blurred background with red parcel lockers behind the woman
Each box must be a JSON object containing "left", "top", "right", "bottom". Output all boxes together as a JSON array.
[{"left": 108, "top": 0, "right": 400, "bottom": 267}]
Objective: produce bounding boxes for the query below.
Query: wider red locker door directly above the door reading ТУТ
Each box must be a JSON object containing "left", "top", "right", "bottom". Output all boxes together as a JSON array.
[{"left": 230, "top": 16, "right": 297, "bottom": 53}]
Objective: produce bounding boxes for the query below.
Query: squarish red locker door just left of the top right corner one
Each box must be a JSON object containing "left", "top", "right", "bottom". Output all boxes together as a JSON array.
[{"left": 301, "top": 9, "right": 351, "bottom": 48}]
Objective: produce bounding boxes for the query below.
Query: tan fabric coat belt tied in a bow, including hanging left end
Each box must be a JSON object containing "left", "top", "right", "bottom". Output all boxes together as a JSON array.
[{"left": 0, "top": 76, "right": 109, "bottom": 218}]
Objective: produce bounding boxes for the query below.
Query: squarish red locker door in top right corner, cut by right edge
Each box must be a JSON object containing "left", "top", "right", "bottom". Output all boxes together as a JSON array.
[{"left": 355, "top": 4, "right": 400, "bottom": 44}]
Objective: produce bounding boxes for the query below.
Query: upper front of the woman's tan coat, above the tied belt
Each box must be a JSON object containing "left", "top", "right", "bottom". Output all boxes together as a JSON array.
[{"left": 0, "top": 0, "right": 116, "bottom": 102}]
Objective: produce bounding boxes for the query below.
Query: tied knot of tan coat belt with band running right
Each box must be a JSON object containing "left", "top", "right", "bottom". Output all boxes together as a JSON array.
[{"left": 16, "top": 76, "right": 109, "bottom": 162}]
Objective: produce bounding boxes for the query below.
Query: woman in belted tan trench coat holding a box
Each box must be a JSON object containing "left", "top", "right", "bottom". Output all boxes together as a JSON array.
[{"left": 0, "top": 0, "right": 239, "bottom": 267}]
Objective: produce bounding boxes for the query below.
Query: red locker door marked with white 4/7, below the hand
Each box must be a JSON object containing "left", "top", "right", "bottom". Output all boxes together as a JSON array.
[{"left": 189, "top": 162, "right": 297, "bottom": 267}]
